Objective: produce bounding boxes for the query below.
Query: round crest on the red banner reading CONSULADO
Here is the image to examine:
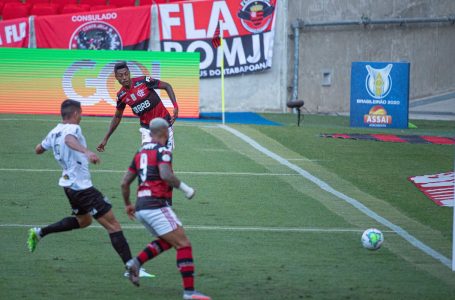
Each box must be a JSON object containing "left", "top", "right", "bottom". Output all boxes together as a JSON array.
[{"left": 69, "top": 21, "right": 123, "bottom": 50}]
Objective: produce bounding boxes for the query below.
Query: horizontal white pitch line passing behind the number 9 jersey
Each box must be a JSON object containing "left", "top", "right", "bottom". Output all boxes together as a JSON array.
[{"left": 0, "top": 168, "right": 299, "bottom": 176}]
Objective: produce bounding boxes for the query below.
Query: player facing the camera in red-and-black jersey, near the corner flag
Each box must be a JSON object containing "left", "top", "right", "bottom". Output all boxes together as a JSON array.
[{"left": 97, "top": 61, "right": 179, "bottom": 152}]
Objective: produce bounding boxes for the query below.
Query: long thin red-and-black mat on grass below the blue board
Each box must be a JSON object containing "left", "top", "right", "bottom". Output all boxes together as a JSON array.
[{"left": 321, "top": 133, "right": 455, "bottom": 145}]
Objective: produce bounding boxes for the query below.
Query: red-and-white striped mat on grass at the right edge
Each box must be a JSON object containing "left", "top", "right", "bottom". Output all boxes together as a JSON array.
[{"left": 408, "top": 172, "right": 455, "bottom": 206}]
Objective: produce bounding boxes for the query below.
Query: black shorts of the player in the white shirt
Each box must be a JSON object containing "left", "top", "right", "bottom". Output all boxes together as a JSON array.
[{"left": 64, "top": 187, "right": 112, "bottom": 219}]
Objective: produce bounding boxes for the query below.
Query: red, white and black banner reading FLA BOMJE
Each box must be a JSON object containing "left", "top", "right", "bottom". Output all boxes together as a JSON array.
[{"left": 158, "top": 0, "right": 278, "bottom": 78}]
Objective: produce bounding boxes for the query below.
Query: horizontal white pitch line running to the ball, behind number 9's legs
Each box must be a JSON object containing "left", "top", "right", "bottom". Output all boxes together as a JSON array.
[{"left": 0, "top": 224, "right": 392, "bottom": 233}]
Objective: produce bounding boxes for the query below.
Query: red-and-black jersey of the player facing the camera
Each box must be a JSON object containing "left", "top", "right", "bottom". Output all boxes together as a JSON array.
[{"left": 117, "top": 76, "right": 171, "bottom": 128}]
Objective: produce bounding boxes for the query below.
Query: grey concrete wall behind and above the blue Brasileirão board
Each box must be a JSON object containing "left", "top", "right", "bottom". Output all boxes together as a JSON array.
[{"left": 288, "top": 0, "right": 455, "bottom": 113}]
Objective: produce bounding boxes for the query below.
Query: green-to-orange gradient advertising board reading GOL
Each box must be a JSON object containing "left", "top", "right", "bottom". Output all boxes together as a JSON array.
[{"left": 0, "top": 48, "right": 199, "bottom": 117}]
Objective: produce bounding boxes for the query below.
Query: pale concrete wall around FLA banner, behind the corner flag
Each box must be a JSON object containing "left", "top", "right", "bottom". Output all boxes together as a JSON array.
[{"left": 150, "top": 0, "right": 289, "bottom": 112}]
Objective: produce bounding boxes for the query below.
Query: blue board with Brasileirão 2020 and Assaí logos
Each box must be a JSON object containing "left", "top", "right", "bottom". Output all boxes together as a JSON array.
[{"left": 350, "top": 62, "right": 410, "bottom": 128}]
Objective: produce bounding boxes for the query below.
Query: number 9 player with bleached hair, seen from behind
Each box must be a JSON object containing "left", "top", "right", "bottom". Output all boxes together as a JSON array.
[{"left": 122, "top": 118, "right": 210, "bottom": 300}]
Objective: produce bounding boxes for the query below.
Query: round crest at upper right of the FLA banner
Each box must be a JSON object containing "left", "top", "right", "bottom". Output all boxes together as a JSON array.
[{"left": 237, "top": 0, "right": 275, "bottom": 33}]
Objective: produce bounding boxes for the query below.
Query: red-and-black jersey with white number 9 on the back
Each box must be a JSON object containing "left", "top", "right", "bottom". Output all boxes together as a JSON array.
[{"left": 128, "top": 143, "right": 172, "bottom": 210}]
